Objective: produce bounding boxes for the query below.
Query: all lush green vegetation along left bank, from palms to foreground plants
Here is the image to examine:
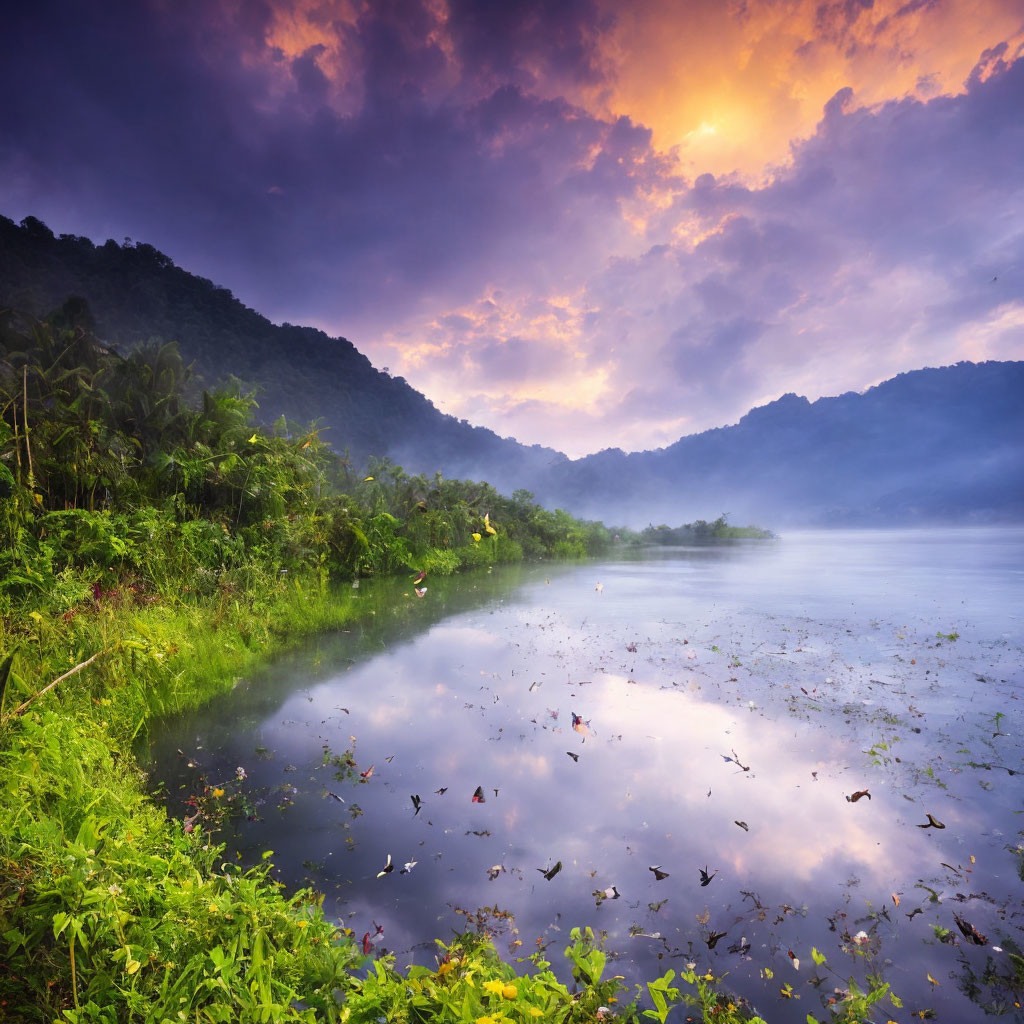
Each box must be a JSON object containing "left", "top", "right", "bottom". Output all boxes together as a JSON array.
[{"left": 0, "top": 304, "right": 884, "bottom": 1024}]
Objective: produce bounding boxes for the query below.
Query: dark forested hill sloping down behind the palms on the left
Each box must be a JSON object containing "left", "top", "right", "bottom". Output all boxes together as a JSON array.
[{"left": 0, "top": 216, "right": 565, "bottom": 493}]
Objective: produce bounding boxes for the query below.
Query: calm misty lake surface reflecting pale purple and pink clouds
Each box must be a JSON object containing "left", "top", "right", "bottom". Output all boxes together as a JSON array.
[{"left": 148, "top": 530, "right": 1024, "bottom": 1021}]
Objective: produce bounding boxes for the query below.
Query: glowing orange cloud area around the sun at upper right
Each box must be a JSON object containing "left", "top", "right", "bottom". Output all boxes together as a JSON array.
[{"left": 574, "top": 0, "right": 1024, "bottom": 180}]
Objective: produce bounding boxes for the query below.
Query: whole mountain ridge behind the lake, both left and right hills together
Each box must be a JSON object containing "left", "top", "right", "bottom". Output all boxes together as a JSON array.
[{"left": 0, "top": 210, "right": 1024, "bottom": 526}]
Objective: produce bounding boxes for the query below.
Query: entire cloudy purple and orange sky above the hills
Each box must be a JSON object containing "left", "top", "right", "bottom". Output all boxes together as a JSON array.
[{"left": 0, "top": 0, "right": 1024, "bottom": 457}]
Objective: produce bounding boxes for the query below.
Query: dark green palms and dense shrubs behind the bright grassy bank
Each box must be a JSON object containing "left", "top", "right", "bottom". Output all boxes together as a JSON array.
[{"left": 0, "top": 302, "right": 609, "bottom": 613}]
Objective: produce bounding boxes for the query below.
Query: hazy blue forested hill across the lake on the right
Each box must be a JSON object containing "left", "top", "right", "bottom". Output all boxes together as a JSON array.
[{"left": 538, "top": 361, "right": 1024, "bottom": 526}]
